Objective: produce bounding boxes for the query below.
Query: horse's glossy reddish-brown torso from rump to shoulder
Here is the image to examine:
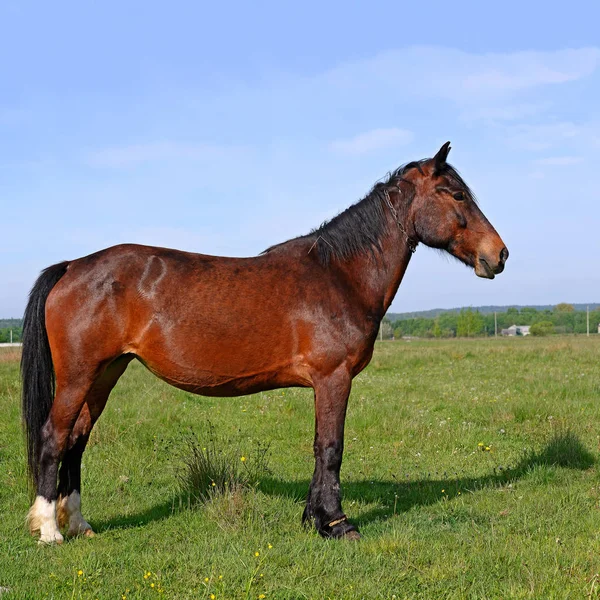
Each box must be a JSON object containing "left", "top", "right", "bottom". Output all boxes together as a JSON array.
[{"left": 47, "top": 244, "right": 338, "bottom": 395}]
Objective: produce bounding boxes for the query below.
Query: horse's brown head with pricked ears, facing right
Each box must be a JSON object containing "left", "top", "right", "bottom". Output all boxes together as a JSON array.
[{"left": 397, "top": 142, "right": 508, "bottom": 279}]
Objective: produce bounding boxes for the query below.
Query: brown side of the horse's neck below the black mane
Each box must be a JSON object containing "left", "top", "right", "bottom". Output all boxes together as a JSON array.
[{"left": 336, "top": 223, "right": 412, "bottom": 318}]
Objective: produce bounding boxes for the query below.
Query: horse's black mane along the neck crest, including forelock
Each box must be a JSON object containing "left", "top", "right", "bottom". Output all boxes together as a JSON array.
[{"left": 265, "top": 159, "right": 475, "bottom": 265}]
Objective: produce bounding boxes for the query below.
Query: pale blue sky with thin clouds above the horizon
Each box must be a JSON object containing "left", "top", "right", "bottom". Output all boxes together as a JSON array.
[{"left": 0, "top": 0, "right": 600, "bottom": 318}]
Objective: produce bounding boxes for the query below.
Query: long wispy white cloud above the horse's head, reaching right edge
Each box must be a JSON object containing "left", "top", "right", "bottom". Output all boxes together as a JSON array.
[{"left": 313, "top": 46, "right": 600, "bottom": 120}]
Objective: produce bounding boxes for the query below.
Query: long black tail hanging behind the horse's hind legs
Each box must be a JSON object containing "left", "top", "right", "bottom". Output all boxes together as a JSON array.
[{"left": 21, "top": 262, "right": 69, "bottom": 484}]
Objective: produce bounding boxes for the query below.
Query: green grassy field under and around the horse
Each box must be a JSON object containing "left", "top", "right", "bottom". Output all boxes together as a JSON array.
[{"left": 0, "top": 336, "right": 600, "bottom": 600}]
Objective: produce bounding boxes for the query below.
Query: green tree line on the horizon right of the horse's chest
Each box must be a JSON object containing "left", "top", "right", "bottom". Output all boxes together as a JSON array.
[{"left": 380, "top": 303, "right": 600, "bottom": 339}]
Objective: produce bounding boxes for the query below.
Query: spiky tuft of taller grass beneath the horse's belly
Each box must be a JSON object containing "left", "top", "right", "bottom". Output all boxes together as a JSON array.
[{"left": 176, "top": 422, "right": 270, "bottom": 504}]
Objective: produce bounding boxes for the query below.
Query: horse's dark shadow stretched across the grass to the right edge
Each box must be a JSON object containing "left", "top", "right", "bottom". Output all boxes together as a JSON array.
[{"left": 93, "top": 432, "right": 595, "bottom": 532}]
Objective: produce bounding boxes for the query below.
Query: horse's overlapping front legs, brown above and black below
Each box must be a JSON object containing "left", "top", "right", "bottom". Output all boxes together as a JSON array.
[{"left": 302, "top": 368, "right": 360, "bottom": 539}]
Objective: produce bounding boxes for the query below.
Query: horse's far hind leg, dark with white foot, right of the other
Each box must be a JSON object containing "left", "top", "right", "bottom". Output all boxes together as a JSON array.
[{"left": 57, "top": 355, "right": 133, "bottom": 537}]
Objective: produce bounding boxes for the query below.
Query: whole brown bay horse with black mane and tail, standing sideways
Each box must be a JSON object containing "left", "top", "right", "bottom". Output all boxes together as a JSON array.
[{"left": 21, "top": 143, "right": 508, "bottom": 543}]
